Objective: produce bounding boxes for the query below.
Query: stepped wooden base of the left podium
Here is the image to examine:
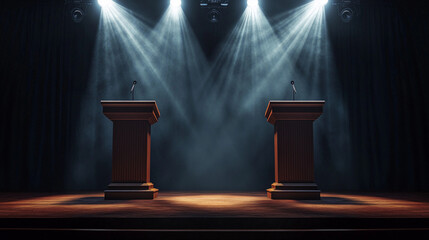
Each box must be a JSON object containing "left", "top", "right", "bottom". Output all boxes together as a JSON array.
[{"left": 104, "top": 183, "right": 158, "bottom": 200}]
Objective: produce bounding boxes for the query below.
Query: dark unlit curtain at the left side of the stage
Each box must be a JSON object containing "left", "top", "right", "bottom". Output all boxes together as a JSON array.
[{"left": 0, "top": 1, "right": 99, "bottom": 191}]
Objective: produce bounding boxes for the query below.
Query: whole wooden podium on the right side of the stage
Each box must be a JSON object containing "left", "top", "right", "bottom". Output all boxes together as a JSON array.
[{"left": 265, "top": 101, "right": 325, "bottom": 199}]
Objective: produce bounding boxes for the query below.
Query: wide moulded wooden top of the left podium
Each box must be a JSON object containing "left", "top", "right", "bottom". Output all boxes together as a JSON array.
[{"left": 101, "top": 100, "right": 160, "bottom": 124}]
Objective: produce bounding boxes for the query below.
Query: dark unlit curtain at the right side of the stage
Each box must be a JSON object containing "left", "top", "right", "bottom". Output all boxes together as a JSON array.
[{"left": 328, "top": 1, "right": 429, "bottom": 191}]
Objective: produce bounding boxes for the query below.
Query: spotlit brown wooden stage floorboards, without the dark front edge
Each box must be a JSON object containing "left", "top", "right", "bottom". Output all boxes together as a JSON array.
[{"left": 0, "top": 192, "right": 429, "bottom": 218}]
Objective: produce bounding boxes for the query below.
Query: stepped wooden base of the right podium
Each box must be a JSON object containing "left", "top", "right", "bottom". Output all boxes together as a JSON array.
[{"left": 267, "top": 183, "right": 320, "bottom": 200}]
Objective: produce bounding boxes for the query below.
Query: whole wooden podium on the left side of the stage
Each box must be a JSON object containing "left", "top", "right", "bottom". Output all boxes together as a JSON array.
[{"left": 101, "top": 101, "right": 159, "bottom": 199}]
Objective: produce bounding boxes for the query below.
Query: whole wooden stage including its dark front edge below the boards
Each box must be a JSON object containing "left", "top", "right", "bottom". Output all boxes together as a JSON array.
[{"left": 0, "top": 191, "right": 429, "bottom": 239}]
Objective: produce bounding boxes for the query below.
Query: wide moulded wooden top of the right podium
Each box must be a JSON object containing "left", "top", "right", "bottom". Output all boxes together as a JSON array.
[{"left": 265, "top": 100, "right": 325, "bottom": 124}]
